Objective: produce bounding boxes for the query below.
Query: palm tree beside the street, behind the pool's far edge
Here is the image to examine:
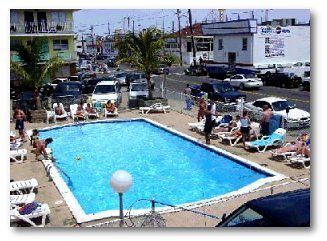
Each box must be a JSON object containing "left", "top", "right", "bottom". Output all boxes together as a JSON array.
[{"left": 116, "top": 28, "right": 165, "bottom": 99}]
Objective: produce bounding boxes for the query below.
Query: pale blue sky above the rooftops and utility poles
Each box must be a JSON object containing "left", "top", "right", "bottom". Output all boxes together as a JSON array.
[{"left": 74, "top": 9, "right": 310, "bottom": 35}]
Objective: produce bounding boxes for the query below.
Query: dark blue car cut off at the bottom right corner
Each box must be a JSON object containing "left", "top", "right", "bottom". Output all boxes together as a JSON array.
[{"left": 216, "top": 189, "right": 310, "bottom": 227}]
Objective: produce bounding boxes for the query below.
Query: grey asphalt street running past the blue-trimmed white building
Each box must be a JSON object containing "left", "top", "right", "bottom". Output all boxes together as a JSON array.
[{"left": 153, "top": 67, "right": 310, "bottom": 111}]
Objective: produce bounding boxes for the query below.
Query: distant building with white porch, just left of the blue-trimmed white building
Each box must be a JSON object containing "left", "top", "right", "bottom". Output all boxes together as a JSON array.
[{"left": 165, "top": 23, "right": 213, "bottom": 65}]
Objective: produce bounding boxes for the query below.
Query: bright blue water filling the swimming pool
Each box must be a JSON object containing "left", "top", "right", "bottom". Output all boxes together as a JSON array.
[{"left": 40, "top": 120, "right": 268, "bottom": 214}]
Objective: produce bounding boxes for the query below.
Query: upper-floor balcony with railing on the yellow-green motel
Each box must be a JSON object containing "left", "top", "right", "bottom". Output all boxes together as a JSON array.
[{"left": 10, "top": 21, "right": 74, "bottom": 35}]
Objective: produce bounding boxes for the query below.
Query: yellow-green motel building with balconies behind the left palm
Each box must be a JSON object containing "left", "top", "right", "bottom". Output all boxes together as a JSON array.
[{"left": 10, "top": 9, "right": 77, "bottom": 86}]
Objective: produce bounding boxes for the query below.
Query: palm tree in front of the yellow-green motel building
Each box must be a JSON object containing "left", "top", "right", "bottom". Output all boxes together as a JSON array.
[{"left": 10, "top": 38, "right": 64, "bottom": 110}]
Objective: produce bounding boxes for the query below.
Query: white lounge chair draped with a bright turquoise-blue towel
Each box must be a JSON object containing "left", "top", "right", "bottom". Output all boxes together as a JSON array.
[{"left": 245, "top": 128, "right": 286, "bottom": 152}]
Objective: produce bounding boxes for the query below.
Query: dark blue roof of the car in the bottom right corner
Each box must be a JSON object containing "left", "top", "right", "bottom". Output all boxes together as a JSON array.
[{"left": 245, "top": 189, "right": 310, "bottom": 227}]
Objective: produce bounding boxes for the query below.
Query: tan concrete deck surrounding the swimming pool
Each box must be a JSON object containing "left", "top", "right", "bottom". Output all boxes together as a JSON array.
[{"left": 10, "top": 110, "right": 310, "bottom": 227}]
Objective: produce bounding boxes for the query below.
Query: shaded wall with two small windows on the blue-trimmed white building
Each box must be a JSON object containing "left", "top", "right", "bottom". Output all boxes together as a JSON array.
[{"left": 213, "top": 34, "right": 253, "bottom": 64}]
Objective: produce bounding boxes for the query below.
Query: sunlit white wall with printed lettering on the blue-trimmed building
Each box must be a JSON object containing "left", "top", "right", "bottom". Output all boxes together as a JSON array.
[{"left": 253, "top": 26, "right": 310, "bottom": 65}]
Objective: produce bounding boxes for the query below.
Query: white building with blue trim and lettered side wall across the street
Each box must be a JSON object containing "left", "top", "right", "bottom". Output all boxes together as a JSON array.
[{"left": 202, "top": 19, "right": 310, "bottom": 68}]
